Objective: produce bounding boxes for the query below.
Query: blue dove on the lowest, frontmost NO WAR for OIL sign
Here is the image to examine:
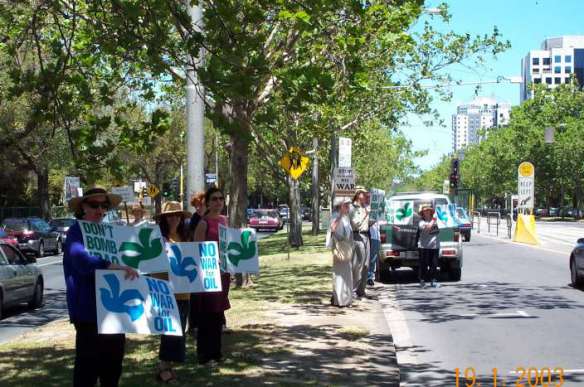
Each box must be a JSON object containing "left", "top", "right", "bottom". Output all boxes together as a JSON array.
[{"left": 99, "top": 274, "right": 144, "bottom": 321}]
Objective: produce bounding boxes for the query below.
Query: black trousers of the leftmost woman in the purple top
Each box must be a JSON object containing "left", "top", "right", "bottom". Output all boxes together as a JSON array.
[{"left": 73, "top": 323, "right": 126, "bottom": 387}]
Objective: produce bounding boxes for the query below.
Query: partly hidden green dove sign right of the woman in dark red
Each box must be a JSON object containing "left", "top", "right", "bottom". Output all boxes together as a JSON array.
[{"left": 219, "top": 225, "right": 260, "bottom": 274}]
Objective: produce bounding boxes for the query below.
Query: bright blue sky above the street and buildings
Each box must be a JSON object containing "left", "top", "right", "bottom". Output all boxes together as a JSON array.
[{"left": 400, "top": 0, "right": 584, "bottom": 170}]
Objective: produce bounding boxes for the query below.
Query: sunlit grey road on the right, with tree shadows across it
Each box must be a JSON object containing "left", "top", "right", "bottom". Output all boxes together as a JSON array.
[{"left": 380, "top": 233, "right": 584, "bottom": 387}]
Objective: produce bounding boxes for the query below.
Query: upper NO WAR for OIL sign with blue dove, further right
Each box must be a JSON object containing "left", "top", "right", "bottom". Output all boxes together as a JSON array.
[{"left": 166, "top": 242, "right": 221, "bottom": 293}]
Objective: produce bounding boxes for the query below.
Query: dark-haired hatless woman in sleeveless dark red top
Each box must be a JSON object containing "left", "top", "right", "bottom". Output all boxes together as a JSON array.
[{"left": 195, "top": 187, "right": 231, "bottom": 364}]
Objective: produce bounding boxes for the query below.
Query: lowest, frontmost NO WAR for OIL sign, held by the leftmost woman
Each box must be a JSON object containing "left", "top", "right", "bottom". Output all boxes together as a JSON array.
[{"left": 95, "top": 270, "right": 182, "bottom": 336}]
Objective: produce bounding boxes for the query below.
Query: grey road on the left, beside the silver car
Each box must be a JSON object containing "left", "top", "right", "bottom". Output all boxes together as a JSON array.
[{"left": 0, "top": 232, "right": 272, "bottom": 343}]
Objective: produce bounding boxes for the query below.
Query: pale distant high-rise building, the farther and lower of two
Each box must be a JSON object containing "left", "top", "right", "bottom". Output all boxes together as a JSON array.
[{"left": 452, "top": 97, "right": 511, "bottom": 152}]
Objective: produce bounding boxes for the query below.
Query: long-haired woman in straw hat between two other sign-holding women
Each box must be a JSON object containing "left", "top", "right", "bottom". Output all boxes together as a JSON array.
[{"left": 152, "top": 201, "right": 191, "bottom": 383}]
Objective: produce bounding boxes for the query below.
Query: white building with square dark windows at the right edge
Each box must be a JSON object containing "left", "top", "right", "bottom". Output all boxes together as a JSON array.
[{"left": 521, "top": 35, "right": 584, "bottom": 102}]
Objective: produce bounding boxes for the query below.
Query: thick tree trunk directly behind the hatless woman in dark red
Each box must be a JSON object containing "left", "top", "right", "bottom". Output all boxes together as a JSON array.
[{"left": 228, "top": 134, "right": 251, "bottom": 287}]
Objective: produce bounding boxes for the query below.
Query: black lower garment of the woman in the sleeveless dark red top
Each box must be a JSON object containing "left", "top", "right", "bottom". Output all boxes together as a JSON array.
[{"left": 197, "top": 312, "right": 224, "bottom": 363}]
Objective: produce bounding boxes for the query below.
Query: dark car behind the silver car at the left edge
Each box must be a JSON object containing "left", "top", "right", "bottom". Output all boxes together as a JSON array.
[{"left": 2, "top": 217, "right": 63, "bottom": 257}]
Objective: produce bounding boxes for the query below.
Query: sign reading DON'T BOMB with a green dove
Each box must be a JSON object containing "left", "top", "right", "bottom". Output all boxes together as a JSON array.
[{"left": 79, "top": 221, "right": 168, "bottom": 273}]
